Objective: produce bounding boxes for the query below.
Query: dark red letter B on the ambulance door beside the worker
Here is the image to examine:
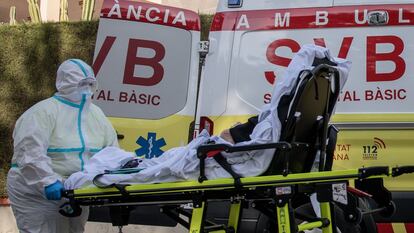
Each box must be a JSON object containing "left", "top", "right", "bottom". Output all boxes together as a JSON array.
[{"left": 123, "top": 39, "right": 165, "bottom": 86}]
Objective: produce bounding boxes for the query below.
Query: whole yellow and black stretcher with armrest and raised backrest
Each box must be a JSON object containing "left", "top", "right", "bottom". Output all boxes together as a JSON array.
[{"left": 61, "top": 59, "right": 414, "bottom": 233}]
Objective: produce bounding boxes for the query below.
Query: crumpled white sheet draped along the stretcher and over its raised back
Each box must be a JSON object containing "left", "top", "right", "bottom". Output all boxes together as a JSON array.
[{"left": 65, "top": 45, "right": 351, "bottom": 189}]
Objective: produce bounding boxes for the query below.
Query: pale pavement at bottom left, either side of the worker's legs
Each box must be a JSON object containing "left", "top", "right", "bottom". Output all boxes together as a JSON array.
[{"left": 0, "top": 205, "right": 188, "bottom": 233}]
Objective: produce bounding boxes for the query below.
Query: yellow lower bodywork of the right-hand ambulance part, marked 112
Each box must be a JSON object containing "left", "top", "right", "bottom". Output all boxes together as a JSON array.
[{"left": 209, "top": 114, "right": 414, "bottom": 191}]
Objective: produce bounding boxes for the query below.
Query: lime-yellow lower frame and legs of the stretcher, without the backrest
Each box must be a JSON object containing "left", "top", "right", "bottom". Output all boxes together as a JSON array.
[{"left": 65, "top": 166, "right": 414, "bottom": 233}]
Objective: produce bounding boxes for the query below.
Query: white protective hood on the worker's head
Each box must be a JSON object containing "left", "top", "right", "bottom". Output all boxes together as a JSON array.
[{"left": 56, "top": 59, "right": 96, "bottom": 102}]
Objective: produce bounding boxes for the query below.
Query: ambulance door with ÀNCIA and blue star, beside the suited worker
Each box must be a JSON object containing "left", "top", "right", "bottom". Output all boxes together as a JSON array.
[{"left": 93, "top": 0, "right": 200, "bottom": 158}]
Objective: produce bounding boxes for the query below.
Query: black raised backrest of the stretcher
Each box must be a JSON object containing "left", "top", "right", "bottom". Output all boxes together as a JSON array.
[{"left": 264, "top": 60, "right": 340, "bottom": 175}]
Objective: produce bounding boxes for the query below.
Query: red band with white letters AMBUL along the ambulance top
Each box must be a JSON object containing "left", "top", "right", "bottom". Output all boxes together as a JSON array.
[{"left": 211, "top": 4, "right": 414, "bottom": 31}]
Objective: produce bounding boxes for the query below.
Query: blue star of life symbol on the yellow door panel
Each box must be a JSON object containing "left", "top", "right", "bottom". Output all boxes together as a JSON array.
[{"left": 135, "top": 132, "right": 167, "bottom": 159}]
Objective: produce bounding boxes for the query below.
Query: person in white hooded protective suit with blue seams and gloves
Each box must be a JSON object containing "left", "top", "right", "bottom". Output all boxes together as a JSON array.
[{"left": 7, "top": 59, "right": 118, "bottom": 233}]
